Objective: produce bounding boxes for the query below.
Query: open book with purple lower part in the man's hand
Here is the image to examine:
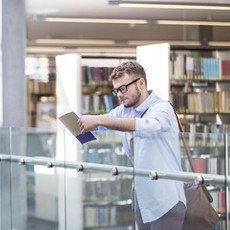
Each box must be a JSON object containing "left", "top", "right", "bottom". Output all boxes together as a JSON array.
[{"left": 58, "top": 112, "right": 96, "bottom": 144}]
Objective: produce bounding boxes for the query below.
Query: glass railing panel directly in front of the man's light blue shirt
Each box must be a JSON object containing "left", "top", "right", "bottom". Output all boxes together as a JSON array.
[{"left": 133, "top": 132, "right": 225, "bottom": 229}]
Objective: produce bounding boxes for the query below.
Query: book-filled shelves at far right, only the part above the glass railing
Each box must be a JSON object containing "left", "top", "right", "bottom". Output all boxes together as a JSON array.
[{"left": 170, "top": 51, "right": 230, "bottom": 133}]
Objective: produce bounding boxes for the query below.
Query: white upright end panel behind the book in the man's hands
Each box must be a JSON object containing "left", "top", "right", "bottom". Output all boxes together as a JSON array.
[{"left": 56, "top": 54, "right": 83, "bottom": 230}]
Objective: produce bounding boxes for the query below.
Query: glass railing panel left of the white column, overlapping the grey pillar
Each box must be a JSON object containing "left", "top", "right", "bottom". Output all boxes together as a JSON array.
[{"left": 11, "top": 129, "right": 58, "bottom": 230}]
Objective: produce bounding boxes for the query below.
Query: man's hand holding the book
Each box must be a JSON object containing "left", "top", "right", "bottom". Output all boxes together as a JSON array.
[{"left": 78, "top": 115, "right": 100, "bottom": 133}]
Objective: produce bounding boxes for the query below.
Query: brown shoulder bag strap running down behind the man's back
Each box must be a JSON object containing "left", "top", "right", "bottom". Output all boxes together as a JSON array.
[{"left": 170, "top": 103, "right": 213, "bottom": 203}]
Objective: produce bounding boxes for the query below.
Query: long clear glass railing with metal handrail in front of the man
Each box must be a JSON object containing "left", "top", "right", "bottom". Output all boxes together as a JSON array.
[{"left": 0, "top": 128, "right": 230, "bottom": 230}]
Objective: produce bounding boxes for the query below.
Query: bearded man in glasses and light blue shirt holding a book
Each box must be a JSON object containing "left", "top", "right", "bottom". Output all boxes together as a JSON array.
[{"left": 78, "top": 61, "right": 186, "bottom": 230}]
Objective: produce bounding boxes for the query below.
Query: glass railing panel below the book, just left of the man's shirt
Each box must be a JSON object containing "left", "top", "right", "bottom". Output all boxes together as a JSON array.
[{"left": 77, "top": 132, "right": 134, "bottom": 230}]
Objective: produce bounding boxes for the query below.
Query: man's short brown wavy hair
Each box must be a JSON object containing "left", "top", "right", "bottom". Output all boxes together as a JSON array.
[{"left": 109, "top": 61, "right": 147, "bottom": 84}]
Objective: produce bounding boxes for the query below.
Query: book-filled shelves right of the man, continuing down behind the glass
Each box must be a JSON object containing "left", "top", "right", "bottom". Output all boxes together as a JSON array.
[{"left": 170, "top": 51, "right": 230, "bottom": 229}]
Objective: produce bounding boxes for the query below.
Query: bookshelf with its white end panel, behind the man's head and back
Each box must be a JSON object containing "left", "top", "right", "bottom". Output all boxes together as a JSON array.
[{"left": 137, "top": 43, "right": 230, "bottom": 229}]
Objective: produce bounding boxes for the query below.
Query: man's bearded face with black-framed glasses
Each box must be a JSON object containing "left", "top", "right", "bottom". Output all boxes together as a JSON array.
[{"left": 112, "top": 74, "right": 141, "bottom": 108}]
